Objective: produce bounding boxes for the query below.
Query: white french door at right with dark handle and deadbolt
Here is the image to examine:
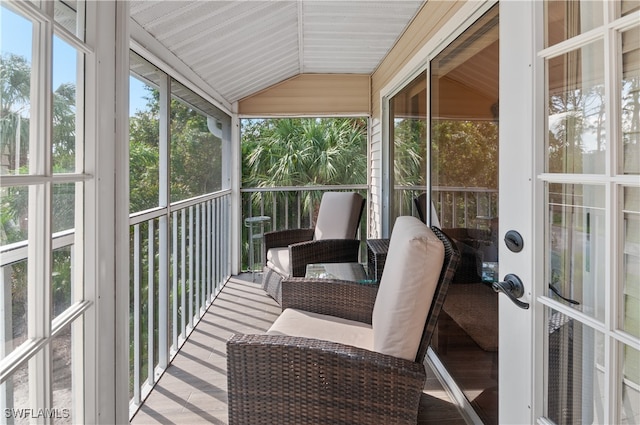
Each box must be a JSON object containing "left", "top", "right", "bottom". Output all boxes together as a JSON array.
[{"left": 499, "top": 1, "right": 640, "bottom": 424}]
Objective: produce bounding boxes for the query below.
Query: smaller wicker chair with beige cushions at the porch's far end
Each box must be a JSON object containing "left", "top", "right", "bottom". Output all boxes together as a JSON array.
[{"left": 262, "top": 192, "right": 365, "bottom": 304}]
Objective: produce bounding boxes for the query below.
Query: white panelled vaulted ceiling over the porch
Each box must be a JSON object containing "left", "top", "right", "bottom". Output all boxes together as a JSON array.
[{"left": 131, "top": 0, "right": 424, "bottom": 103}]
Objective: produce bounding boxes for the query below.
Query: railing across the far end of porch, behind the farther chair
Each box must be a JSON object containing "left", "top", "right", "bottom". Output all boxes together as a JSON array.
[{"left": 240, "top": 184, "right": 368, "bottom": 270}]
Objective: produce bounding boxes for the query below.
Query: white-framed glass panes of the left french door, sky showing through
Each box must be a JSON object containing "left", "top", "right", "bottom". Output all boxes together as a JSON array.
[{"left": 0, "top": 1, "right": 92, "bottom": 424}]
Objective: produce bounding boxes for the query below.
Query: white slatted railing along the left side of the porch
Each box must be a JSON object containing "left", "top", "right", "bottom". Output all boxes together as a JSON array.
[{"left": 129, "top": 191, "right": 231, "bottom": 417}]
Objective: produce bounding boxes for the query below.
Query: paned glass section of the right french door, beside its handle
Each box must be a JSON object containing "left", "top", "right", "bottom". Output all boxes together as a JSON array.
[{"left": 538, "top": 1, "right": 640, "bottom": 424}]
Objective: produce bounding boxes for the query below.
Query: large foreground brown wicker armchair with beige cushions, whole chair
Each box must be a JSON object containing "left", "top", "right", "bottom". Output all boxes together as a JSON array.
[{"left": 227, "top": 217, "right": 459, "bottom": 424}]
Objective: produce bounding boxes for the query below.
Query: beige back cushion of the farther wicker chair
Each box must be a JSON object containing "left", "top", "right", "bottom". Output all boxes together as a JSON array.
[{"left": 314, "top": 192, "right": 364, "bottom": 240}]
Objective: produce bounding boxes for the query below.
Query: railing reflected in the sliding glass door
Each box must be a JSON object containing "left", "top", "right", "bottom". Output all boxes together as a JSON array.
[{"left": 394, "top": 186, "right": 498, "bottom": 228}]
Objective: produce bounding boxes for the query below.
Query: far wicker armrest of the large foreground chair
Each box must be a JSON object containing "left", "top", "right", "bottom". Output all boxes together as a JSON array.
[{"left": 282, "top": 277, "right": 378, "bottom": 324}]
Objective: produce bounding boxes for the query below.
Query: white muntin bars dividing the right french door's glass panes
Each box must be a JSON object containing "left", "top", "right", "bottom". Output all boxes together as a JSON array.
[{"left": 536, "top": 2, "right": 640, "bottom": 423}]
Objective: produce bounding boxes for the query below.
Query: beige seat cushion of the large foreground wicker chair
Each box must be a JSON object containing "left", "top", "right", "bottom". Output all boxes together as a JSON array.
[{"left": 267, "top": 308, "right": 373, "bottom": 350}]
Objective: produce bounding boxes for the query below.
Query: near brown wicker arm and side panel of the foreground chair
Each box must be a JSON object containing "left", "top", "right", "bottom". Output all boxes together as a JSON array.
[{"left": 227, "top": 335, "right": 426, "bottom": 425}]
